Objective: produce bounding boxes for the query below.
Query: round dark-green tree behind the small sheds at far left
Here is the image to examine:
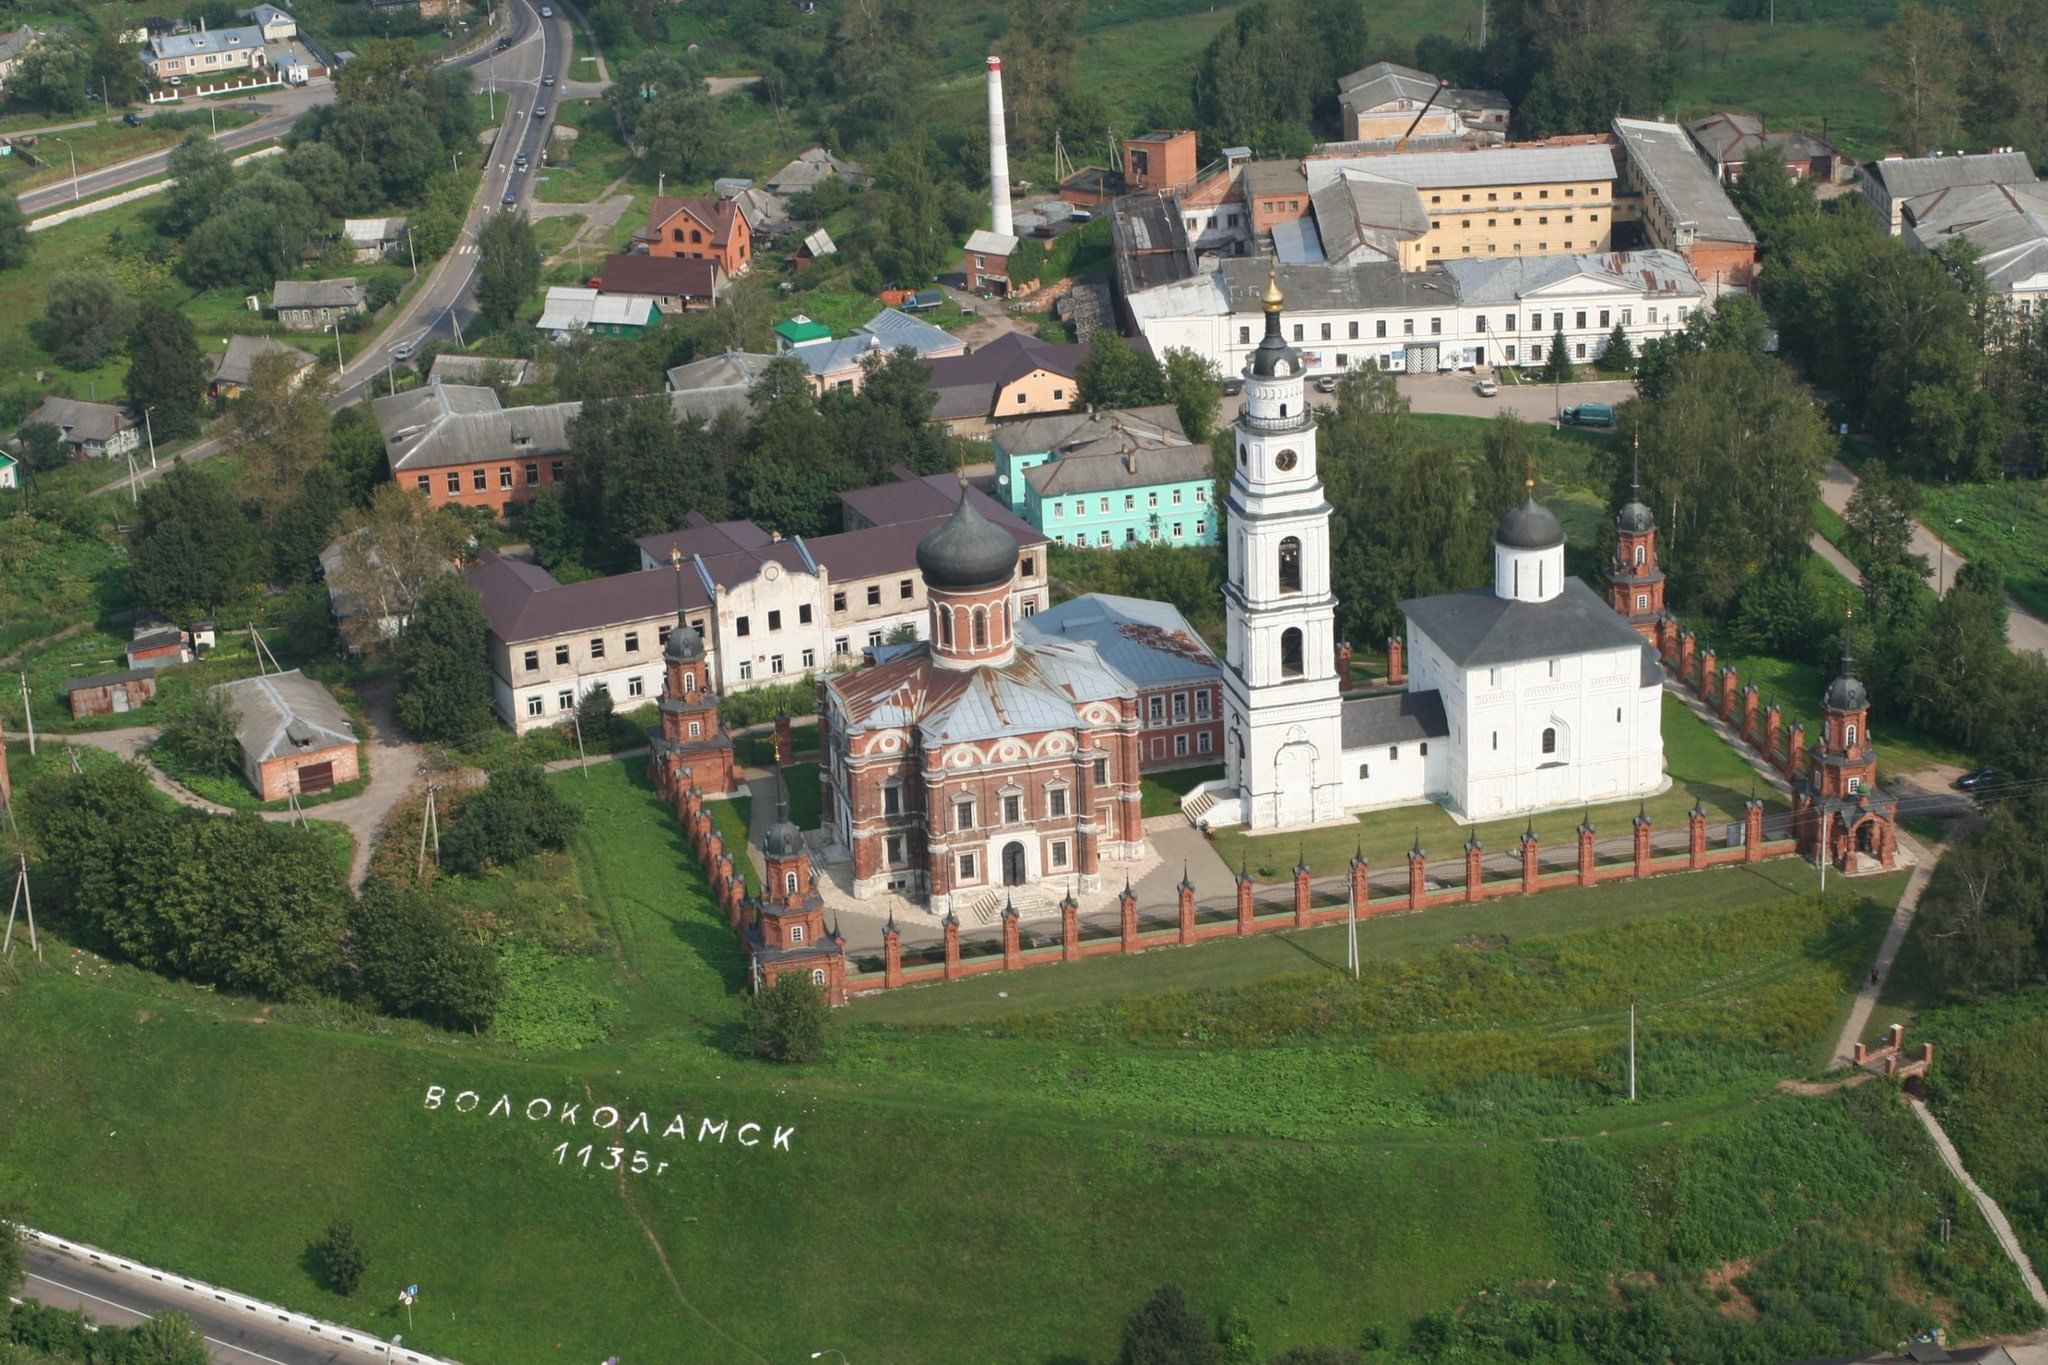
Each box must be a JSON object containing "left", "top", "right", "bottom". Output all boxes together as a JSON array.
[{"left": 129, "top": 465, "right": 256, "bottom": 620}]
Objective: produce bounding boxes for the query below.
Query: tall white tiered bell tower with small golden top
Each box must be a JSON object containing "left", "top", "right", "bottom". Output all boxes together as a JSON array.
[{"left": 1223, "top": 263, "right": 1343, "bottom": 829}]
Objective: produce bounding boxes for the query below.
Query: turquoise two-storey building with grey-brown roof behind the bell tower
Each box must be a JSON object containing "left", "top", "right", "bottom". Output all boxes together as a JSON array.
[{"left": 993, "top": 407, "right": 1217, "bottom": 551}]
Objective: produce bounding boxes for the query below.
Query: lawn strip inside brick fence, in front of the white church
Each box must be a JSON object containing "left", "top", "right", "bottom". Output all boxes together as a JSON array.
[{"left": 1217, "top": 694, "right": 1786, "bottom": 884}]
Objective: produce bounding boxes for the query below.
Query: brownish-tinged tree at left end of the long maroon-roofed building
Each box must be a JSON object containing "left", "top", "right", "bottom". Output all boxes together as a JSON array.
[{"left": 328, "top": 483, "right": 469, "bottom": 649}]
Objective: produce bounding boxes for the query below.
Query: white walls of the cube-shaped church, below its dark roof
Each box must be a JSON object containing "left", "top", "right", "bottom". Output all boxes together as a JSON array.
[{"left": 1441, "top": 647, "right": 1665, "bottom": 821}]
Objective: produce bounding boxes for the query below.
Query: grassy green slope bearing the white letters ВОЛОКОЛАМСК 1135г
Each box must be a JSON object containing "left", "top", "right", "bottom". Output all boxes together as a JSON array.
[{"left": 0, "top": 763, "right": 2031, "bottom": 1363}]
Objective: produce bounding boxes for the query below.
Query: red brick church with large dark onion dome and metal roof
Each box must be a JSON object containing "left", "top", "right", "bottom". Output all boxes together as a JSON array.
[{"left": 819, "top": 493, "right": 1145, "bottom": 915}]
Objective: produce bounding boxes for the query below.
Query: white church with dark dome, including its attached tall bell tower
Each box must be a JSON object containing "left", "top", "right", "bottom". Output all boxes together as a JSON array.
[{"left": 1188, "top": 282, "right": 1667, "bottom": 829}]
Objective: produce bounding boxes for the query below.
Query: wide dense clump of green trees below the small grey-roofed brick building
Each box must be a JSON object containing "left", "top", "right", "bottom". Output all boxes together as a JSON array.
[{"left": 23, "top": 763, "right": 348, "bottom": 999}]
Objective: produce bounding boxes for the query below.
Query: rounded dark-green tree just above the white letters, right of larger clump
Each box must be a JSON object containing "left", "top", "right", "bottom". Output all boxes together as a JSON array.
[{"left": 348, "top": 880, "right": 504, "bottom": 1031}]
